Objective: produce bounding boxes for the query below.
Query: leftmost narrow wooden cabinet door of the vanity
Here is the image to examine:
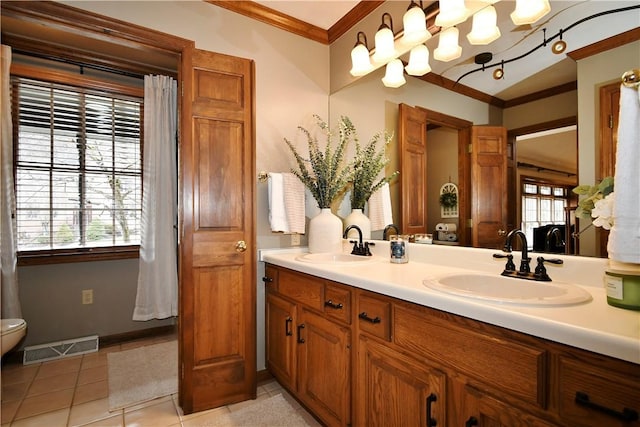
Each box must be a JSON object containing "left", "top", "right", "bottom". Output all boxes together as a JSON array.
[{"left": 265, "top": 292, "right": 297, "bottom": 390}]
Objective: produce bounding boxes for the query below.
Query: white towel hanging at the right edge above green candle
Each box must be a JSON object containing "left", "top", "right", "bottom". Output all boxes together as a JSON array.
[{"left": 607, "top": 85, "right": 640, "bottom": 264}]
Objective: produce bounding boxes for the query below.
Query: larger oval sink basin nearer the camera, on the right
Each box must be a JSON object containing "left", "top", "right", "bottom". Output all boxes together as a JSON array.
[{"left": 423, "top": 273, "right": 591, "bottom": 306}]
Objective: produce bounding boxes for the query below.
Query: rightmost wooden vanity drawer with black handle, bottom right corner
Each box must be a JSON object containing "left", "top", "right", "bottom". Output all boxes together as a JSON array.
[{"left": 558, "top": 357, "right": 640, "bottom": 427}]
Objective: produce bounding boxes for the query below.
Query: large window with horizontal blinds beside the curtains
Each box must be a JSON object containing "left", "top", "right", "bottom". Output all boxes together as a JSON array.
[{"left": 12, "top": 77, "right": 143, "bottom": 252}]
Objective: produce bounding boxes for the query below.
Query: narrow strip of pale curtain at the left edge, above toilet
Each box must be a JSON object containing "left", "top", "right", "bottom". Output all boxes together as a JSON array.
[{"left": 0, "top": 45, "right": 22, "bottom": 319}]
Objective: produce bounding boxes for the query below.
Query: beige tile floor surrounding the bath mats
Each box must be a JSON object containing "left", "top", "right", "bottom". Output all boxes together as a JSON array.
[{"left": 0, "top": 336, "right": 319, "bottom": 427}]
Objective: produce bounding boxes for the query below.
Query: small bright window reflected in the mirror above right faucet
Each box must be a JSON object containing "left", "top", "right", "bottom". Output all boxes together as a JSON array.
[{"left": 522, "top": 181, "right": 569, "bottom": 246}]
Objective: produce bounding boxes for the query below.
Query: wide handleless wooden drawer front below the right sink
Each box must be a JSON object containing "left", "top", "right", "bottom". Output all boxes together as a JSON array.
[{"left": 393, "top": 305, "right": 547, "bottom": 407}]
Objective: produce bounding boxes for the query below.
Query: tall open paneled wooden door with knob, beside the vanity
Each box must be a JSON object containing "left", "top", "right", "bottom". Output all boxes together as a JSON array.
[{"left": 179, "top": 49, "right": 256, "bottom": 414}]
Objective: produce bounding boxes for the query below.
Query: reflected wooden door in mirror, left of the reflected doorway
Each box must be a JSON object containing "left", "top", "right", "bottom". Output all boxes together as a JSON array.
[{"left": 398, "top": 104, "right": 427, "bottom": 234}]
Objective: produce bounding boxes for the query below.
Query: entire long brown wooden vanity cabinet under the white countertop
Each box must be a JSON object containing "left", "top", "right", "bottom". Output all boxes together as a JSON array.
[{"left": 267, "top": 267, "right": 640, "bottom": 427}]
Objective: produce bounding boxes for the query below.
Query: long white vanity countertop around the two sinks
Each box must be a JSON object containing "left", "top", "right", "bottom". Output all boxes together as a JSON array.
[{"left": 259, "top": 241, "right": 640, "bottom": 364}]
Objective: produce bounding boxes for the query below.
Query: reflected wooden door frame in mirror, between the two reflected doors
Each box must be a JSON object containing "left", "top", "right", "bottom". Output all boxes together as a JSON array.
[{"left": 416, "top": 106, "right": 473, "bottom": 246}]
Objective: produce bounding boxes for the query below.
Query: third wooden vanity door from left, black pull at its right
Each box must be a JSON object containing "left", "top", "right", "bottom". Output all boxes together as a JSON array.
[{"left": 354, "top": 336, "right": 449, "bottom": 427}]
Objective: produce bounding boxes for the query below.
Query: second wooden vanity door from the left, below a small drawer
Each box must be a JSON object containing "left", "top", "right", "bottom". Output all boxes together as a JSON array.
[{"left": 296, "top": 308, "right": 351, "bottom": 426}]
